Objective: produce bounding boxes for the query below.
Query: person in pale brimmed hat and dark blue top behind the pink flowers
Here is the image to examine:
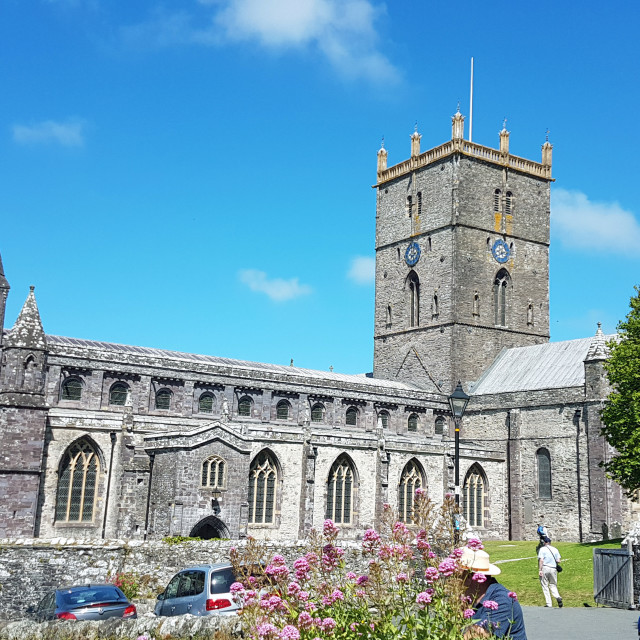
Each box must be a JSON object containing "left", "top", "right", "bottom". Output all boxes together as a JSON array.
[{"left": 458, "top": 541, "right": 527, "bottom": 640}]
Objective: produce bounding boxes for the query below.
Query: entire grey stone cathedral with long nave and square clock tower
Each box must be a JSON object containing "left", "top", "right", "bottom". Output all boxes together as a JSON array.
[{"left": 0, "top": 112, "right": 634, "bottom": 541}]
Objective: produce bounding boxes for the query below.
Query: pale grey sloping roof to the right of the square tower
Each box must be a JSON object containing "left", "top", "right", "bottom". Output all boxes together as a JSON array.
[{"left": 470, "top": 331, "right": 616, "bottom": 396}]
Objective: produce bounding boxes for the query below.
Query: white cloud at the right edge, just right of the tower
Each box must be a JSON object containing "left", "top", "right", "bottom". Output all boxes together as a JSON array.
[{"left": 551, "top": 189, "right": 640, "bottom": 256}]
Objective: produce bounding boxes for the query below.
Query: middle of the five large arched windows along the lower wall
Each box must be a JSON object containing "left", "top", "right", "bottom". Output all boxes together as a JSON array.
[{"left": 325, "top": 452, "right": 360, "bottom": 527}]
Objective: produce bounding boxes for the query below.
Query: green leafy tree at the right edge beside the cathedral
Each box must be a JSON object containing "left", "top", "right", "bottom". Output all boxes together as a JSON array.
[{"left": 602, "top": 286, "right": 640, "bottom": 493}]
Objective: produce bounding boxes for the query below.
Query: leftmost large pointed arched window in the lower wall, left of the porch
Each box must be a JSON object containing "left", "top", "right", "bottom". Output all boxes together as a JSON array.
[{"left": 56, "top": 438, "right": 100, "bottom": 522}]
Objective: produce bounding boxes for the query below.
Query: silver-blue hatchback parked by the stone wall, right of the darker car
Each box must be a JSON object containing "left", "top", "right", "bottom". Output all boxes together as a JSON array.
[{"left": 154, "top": 562, "right": 239, "bottom": 616}]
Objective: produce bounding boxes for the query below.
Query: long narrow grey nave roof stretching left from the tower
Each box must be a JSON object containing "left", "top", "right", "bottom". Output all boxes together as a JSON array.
[{"left": 47, "top": 336, "right": 424, "bottom": 391}]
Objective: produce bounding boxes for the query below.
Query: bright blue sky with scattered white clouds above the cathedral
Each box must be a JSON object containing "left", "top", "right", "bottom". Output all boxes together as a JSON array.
[{"left": 0, "top": 0, "right": 640, "bottom": 373}]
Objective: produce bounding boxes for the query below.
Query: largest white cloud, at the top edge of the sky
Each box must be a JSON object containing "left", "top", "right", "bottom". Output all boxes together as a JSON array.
[{"left": 122, "top": 0, "right": 399, "bottom": 82}]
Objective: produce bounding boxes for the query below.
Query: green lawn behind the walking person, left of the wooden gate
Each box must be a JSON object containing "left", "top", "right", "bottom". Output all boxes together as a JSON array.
[{"left": 484, "top": 540, "right": 620, "bottom": 607}]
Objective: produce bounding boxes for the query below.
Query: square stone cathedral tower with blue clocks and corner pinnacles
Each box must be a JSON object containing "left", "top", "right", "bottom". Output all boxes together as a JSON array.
[{"left": 374, "top": 111, "right": 552, "bottom": 393}]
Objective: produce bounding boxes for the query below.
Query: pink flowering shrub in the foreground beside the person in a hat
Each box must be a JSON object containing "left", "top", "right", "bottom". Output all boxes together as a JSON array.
[{"left": 231, "top": 490, "right": 516, "bottom": 640}]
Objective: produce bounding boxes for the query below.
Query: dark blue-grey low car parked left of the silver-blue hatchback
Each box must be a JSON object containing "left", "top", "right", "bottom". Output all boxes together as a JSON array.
[{"left": 27, "top": 584, "right": 138, "bottom": 622}]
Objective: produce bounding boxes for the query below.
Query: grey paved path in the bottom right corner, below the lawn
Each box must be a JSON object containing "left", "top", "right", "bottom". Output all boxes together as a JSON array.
[{"left": 522, "top": 607, "right": 640, "bottom": 640}]
